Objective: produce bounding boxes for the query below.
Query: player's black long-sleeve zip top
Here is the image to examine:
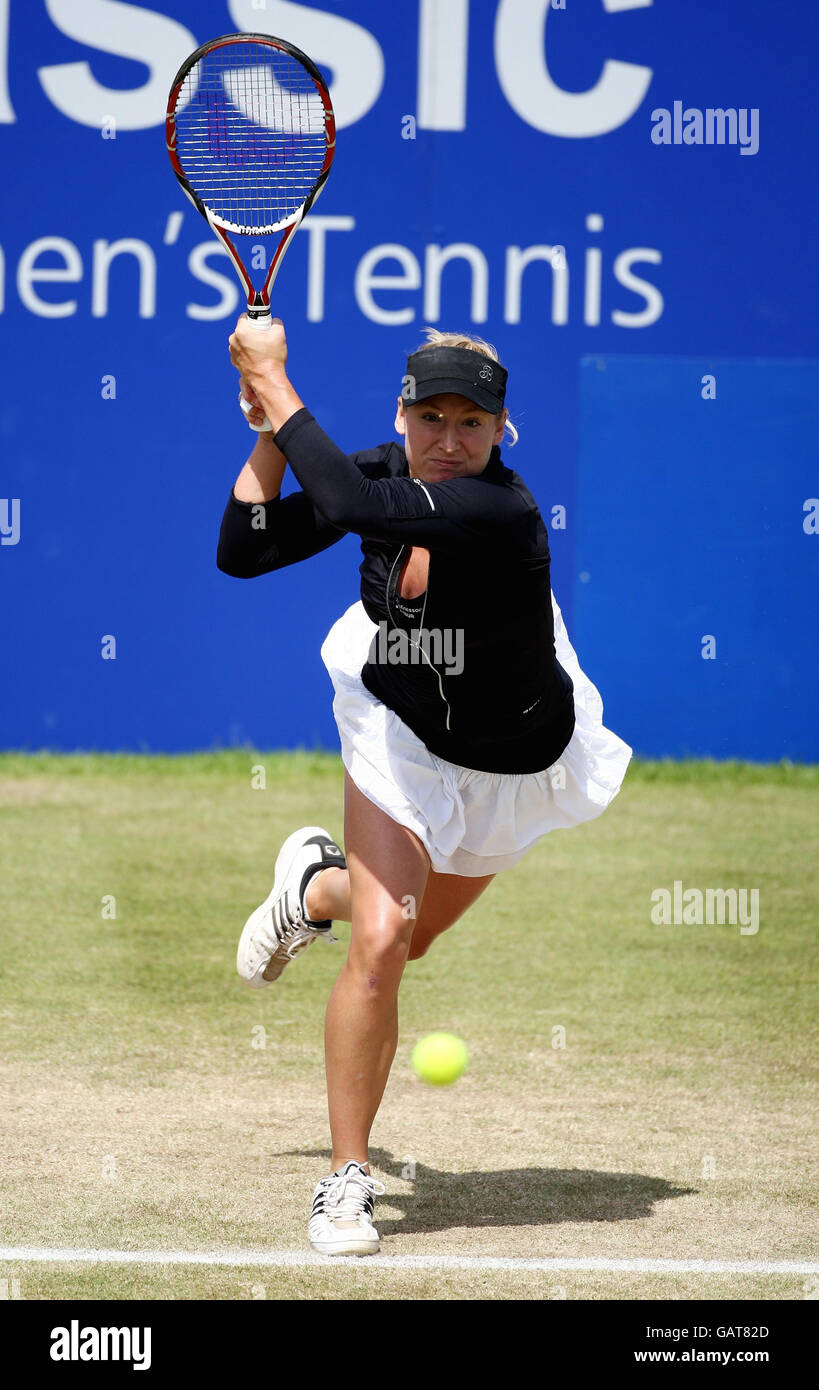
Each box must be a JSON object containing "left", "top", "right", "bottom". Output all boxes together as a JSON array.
[{"left": 217, "top": 410, "right": 574, "bottom": 773}]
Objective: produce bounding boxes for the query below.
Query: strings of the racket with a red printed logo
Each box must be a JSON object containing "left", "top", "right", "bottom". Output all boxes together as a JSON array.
[{"left": 175, "top": 42, "right": 327, "bottom": 234}]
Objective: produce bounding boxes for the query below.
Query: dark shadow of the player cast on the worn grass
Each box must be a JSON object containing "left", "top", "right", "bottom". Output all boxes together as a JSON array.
[{"left": 282, "top": 1148, "right": 697, "bottom": 1236}]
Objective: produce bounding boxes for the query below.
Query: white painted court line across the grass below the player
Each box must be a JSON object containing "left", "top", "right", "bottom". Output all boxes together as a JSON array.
[{"left": 0, "top": 1245, "right": 819, "bottom": 1275}]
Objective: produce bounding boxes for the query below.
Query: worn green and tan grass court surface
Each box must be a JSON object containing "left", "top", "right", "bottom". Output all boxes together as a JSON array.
[{"left": 0, "top": 749, "right": 819, "bottom": 1298}]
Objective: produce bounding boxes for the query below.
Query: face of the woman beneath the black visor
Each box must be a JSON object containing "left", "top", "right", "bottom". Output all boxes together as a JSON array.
[{"left": 395, "top": 396, "right": 506, "bottom": 482}]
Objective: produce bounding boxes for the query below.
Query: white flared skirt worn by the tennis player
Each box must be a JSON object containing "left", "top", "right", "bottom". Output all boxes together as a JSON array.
[{"left": 321, "top": 595, "right": 631, "bottom": 878}]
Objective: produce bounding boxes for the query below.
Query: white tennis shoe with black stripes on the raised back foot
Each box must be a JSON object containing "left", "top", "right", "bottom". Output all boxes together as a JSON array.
[{"left": 236, "top": 826, "right": 346, "bottom": 990}]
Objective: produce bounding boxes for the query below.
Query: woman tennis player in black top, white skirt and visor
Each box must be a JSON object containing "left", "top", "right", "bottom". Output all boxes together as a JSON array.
[{"left": 217, "top": 317, "right": 631, "bottom": 1255}]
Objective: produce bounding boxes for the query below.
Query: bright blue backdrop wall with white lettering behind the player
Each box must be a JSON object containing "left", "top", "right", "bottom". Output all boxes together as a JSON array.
[{"left": 0, "top": 0, "right": 819, "bottom": 759}]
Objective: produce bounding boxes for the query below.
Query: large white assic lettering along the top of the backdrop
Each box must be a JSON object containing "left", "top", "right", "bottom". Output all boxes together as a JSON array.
[{"left": 0, "top": 0, "right": 654, "bottom": 139}]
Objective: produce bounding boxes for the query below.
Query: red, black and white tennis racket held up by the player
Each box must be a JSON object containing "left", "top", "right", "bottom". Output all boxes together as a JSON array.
[{"left": 165, "top": 33, "right": 335, "bottom": 431}]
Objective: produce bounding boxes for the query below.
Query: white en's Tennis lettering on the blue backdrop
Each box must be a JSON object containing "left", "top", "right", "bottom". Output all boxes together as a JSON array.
[{"left": 6, "top": 211, "right": 665, "bottom": 325}]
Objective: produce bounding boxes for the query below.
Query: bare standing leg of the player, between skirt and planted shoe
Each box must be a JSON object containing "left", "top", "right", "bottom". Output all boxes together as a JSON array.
[{"left": 324, "top": 774, "right": 430, "bottom": 1170}]
